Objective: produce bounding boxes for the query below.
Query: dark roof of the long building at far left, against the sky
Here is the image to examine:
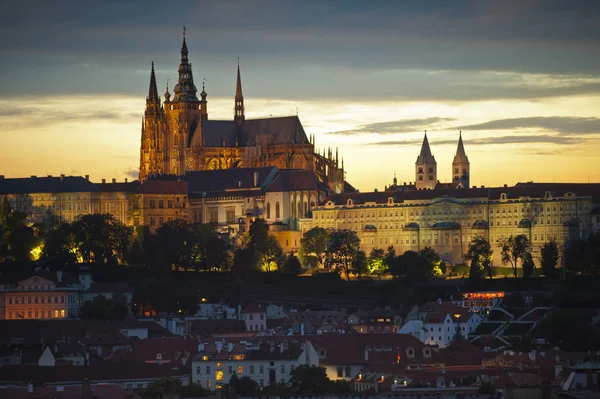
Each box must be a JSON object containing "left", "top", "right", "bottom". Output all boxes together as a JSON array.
[{"left": 0, "top": 176, "right": 99, "bottom": 194}]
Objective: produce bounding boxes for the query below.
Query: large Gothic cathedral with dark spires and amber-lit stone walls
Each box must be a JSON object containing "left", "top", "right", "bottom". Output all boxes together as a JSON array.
[{"left": 140, "top": 33, "right": 344, "bottom": 192}]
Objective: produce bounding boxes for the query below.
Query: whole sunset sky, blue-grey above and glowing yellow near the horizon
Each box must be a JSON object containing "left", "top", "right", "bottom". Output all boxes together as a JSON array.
[{"left": 0, "top": 0, "right": 600, "bottom": 191}]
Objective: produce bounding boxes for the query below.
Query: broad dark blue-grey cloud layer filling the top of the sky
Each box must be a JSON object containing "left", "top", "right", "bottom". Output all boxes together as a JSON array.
[{"left": 0, "top": 0, "right": 600, "bottom": 100}]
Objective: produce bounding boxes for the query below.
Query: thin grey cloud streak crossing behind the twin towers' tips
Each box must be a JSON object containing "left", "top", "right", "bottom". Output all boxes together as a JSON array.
[{"left": 368, "top": 135, "right": 585, "bottom": 147}]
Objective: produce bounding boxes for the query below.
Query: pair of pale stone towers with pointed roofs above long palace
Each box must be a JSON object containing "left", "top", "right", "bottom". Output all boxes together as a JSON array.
[{"left": 415, "top": 131, "right": 470, "bottom": 190}]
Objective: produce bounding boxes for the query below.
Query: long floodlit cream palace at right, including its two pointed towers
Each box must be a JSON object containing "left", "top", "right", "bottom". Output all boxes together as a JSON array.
[{"left": 300, "top": 136, "right": 600, "bottom": 265}]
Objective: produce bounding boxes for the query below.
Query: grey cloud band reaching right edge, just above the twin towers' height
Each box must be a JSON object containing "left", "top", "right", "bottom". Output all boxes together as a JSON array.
[{"left": 454, "top": 116, "right": 600, "bottom": 134}]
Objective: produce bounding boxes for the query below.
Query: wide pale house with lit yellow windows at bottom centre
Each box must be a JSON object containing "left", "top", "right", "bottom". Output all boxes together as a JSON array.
[{"left": 192, "top": 340, "right": 319, "bottom": 390}]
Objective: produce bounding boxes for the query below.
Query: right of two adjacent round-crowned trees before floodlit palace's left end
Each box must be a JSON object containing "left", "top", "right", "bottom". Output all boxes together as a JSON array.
[{"left": 324, "top": 230, "right": 360, "bottom": 280}]
